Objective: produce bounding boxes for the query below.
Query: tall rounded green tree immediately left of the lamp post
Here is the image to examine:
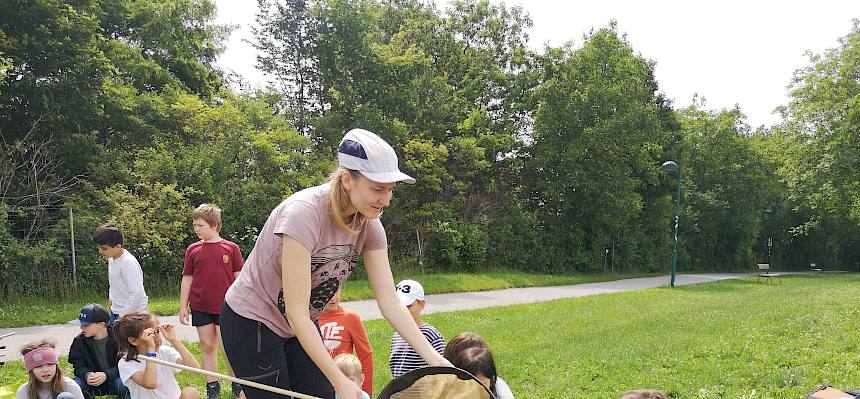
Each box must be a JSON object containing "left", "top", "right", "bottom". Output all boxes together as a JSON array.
[{"left": 524, "top": 28, "right": 675, "bottom": 271}]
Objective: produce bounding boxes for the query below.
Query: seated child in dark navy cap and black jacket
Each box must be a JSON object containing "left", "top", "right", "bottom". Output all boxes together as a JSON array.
[{"left": 69, "top": 303, "right": 129, "bottom": 399}]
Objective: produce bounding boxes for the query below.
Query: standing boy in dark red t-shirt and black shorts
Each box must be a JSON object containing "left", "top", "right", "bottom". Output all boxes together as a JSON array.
[{"left": 179, "top": 204, "right": 244, "bottom": 399}]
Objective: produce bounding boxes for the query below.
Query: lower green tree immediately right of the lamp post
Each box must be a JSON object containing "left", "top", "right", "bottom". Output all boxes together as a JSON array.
[{"left": 679, "top": 108, "right": 771, "bottom": 270}]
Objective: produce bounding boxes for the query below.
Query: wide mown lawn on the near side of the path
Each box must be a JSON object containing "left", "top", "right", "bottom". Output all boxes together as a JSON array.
[{"left": 5, "top": 274, "right": 860, "bottom": 399}]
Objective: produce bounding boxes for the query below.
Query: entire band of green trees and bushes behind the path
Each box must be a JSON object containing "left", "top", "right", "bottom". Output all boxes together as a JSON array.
[{"left": 0, "top": 0, "right": 860, "bottom": 296}]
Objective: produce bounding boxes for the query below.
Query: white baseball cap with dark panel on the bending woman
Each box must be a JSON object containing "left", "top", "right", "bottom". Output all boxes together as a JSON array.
[{"left": 337, "top": 129, "right": 415, "bottom": 184}]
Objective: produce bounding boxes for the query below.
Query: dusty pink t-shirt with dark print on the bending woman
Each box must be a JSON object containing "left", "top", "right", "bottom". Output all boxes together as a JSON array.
[{"left": 225, "top": 183, "right": 388, "bottom": 338}]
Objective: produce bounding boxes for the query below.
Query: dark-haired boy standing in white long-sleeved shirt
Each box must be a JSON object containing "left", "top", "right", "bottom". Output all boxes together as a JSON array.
[{"left": 93, "top": 224, "right": 149, "bottom": 326}]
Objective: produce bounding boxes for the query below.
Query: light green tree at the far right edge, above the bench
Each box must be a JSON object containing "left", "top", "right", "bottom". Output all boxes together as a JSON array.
[{"left": 773, "top": 20, "right": 860, "bottom": 269}]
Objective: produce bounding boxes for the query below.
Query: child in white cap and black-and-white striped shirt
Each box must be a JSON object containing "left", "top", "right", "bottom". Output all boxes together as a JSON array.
[{"left": 388, "top": 280, "right": 445, "bottom": 378}]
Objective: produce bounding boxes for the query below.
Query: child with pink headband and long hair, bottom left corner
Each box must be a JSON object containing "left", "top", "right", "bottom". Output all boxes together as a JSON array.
[{"left": 15, "top": 340, "right": 84, "bottom": 399}]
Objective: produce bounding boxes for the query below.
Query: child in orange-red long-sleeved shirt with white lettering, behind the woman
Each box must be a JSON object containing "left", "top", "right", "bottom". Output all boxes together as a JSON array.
[{"left": 319, "top": 289, "right": 373, "bottom": 393}]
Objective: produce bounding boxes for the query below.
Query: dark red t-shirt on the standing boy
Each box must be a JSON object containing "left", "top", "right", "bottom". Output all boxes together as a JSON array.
[{"left": 182, "top": 240, "right": 245, "bottom": 314}]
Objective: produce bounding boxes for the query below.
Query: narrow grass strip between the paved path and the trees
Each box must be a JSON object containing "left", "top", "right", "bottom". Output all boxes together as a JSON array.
[{"left": 0, "top": 272, "right": 656, "bottom": 328}]
